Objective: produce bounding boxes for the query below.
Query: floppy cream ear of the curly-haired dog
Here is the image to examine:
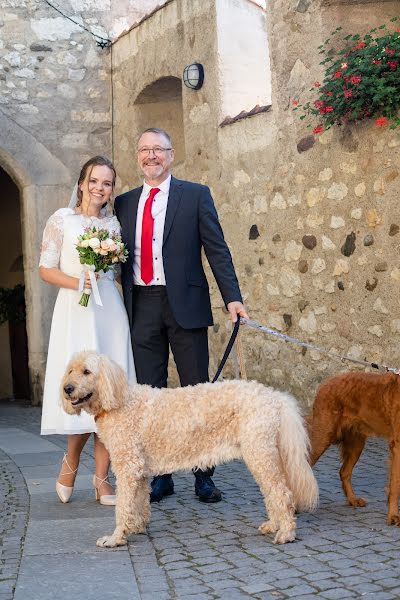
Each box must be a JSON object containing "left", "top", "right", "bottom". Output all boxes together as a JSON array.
[{"left": 97, "top": 354, "right": 128, "bottom": 411}]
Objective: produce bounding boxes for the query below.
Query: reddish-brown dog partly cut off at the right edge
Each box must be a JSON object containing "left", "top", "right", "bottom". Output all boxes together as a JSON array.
[{"left": 307, "top": 372, "right": 400, "bottom": 526}]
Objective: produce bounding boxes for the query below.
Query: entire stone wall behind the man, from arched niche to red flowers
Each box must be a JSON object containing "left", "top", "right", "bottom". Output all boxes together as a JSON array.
[{"left": 114, "top": 0, "right": 400, "bottom": 404}]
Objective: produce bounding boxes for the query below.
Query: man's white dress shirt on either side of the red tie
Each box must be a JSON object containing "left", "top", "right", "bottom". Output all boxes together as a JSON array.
[{"left": 133, "top": 175, "right": 171, "bottom": 285}]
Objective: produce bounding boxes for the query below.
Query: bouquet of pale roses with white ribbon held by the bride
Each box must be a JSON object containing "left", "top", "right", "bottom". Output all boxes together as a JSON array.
[{"left": 76, "top": 227, "right": 128, "bottom": 306}]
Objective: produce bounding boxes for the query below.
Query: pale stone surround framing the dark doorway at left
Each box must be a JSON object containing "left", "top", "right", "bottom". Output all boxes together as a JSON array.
[{"left": 0, "top": 112, "right": 72, "bottom": 404}]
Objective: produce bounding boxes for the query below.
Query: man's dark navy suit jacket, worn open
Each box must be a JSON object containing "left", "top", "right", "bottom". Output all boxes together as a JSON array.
[{"left": 115, "top": 177, "right": 242, "bottom": 329}]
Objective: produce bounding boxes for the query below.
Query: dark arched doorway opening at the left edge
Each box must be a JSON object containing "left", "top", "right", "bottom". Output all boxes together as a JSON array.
[{"left": 0, "top": 167, "right": 30, "bottom": 399}]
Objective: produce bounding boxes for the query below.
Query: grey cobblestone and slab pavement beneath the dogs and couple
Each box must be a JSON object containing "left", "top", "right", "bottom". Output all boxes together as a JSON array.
[{"left": 0, "top": 398, "right": 400, "bottom": 600}]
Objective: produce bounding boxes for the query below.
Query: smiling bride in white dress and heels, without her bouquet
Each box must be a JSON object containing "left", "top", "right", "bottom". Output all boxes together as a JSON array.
[{"left": 39, "top": 156, "right": 136, "bottom": 505}]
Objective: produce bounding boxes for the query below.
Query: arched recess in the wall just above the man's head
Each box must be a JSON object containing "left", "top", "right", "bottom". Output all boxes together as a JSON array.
[{"left": 132, "top": 77, "right": 185, "bottom": 164}]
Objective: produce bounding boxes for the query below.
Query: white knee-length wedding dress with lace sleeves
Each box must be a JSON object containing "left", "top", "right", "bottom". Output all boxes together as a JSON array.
[{"left": 39, "top": 208, "right": 136, "bottom": 435}]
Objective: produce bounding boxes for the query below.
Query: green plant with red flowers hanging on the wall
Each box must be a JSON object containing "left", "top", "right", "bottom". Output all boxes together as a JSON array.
[{"left": 292, "top": 17, "right": 400, "bottom": 134}]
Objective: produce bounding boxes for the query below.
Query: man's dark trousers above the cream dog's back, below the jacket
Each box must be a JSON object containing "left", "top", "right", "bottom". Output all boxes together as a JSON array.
[{"left": 131, "top": 286, "right": 208, "bottom": 388}]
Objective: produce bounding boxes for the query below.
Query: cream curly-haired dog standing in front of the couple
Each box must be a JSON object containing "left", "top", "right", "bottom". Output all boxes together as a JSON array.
[{"left": 61, "top": 352, "right": 318, "bottom": 547}]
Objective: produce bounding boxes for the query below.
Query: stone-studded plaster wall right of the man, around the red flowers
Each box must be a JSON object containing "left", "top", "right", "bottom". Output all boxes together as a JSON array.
[{"left": 217, "top": 0, "right": 400, "bottom": 404}]
